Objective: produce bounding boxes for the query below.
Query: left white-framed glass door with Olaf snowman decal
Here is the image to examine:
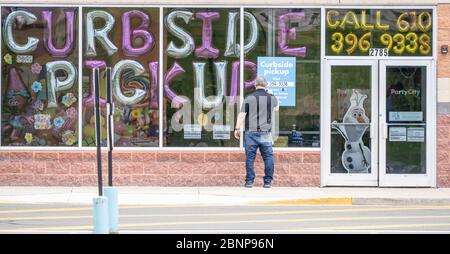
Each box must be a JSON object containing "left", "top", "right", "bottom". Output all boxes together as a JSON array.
[{"left": 322, "top": 60, "right": 378, "bottom": 186}]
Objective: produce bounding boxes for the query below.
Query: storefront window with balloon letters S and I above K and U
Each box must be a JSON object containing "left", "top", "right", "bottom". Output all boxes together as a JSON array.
[{"left": 163, "top": 8, "right": 240, "bottom": 147}]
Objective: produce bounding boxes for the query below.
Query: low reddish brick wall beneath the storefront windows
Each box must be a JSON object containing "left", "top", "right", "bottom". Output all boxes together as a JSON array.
[{"left": 0, "top": 151, "right": 320, "bottom": 187}]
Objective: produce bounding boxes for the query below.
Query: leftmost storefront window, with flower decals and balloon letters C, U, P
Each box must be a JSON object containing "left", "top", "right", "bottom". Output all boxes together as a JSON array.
[{"left": 1, "top": 7, "right": 78, "bottom": 146}]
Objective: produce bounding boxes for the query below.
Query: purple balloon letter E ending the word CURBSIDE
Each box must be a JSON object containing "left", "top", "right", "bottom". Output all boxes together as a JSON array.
[{"left": 278, "top": 11, "right": 306, "bottom": 57}]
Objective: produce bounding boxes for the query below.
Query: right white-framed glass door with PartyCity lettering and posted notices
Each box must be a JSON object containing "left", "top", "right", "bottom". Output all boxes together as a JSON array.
[{"left": 379, "top": 60, "right": 436, "bottom": 187}]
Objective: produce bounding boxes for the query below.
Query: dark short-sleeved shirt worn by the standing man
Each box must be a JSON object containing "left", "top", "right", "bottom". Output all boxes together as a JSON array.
[{"left": 241, "top": 89, "right": 278, "bottom": 131}]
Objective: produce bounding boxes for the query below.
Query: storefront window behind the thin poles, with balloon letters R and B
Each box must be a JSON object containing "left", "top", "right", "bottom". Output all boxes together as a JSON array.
[{"left": 82, "top": 7, "right": 159, "bottom": 147}]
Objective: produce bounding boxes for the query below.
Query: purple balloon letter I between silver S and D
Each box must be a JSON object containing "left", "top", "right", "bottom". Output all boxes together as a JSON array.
[{"left": 195, "top": 11, "right": 220, "bottom": 59}]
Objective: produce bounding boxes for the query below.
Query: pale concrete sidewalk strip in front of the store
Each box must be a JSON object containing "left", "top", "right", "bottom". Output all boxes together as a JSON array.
[{"left": 0, "top": 186, "right": 450, "bottom": 205}]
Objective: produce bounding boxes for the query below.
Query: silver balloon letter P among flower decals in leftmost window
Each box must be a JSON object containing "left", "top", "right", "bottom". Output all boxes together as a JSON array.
[{"left": 45, "top": 61, "right": 77, "bottom": 108}]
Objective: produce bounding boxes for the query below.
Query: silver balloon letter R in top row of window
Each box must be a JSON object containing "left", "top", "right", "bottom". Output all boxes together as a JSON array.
[{"left": 86, "top": 11, "right": 117, "bottom": 57}]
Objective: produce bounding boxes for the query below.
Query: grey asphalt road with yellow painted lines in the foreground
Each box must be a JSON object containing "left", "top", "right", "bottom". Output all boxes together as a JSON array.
[{"left": 0, "top": 203, "right": 450, "bottom": 234}]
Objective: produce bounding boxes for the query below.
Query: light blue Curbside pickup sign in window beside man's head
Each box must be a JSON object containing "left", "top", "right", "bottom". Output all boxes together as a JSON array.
[{"left": 258, "top": 57, "right": 296, "bottom": 107}]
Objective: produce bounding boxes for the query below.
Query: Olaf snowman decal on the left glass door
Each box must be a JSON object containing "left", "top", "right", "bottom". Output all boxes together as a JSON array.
[{"left": 332, "top": 90, "right": 371, "bottom": 173}]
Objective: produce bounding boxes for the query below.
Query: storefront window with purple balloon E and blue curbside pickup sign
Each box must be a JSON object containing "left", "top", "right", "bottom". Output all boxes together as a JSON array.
[{"left": 244, "top": 9, "right": 321, "bottom": 147}]
